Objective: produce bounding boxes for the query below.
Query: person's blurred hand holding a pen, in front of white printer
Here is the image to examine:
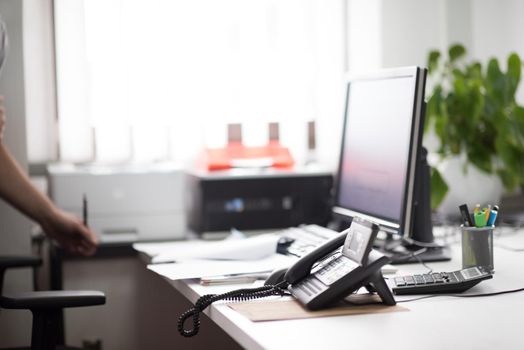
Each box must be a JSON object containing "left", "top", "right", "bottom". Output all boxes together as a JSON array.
[{"left": 40, "top": 209, "right": 98, "bottom": 256}]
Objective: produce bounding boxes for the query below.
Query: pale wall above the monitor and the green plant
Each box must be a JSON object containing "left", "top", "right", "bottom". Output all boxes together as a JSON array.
[{"left": 376, "top": 0, "right": 524, "bottom": 94}]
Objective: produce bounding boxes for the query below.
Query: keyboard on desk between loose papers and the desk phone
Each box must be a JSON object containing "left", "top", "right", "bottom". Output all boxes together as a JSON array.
[{"left": 277, "top": 224, "right": 339, "bottom": 257}]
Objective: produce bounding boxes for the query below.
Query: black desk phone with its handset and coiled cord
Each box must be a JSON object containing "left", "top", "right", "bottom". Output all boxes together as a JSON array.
[{"left": 178, "top": 217, "right": 396, "bottom": 337}]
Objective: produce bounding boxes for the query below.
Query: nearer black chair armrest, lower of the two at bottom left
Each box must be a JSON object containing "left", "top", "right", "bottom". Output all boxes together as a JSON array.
[{"left": 0, "top": 290, "right": 106, "bottom": 310}]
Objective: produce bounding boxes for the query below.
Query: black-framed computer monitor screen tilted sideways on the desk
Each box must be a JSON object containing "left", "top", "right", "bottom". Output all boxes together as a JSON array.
[{"left": 334, "top": 67, "right": 425, "bottom": 233}]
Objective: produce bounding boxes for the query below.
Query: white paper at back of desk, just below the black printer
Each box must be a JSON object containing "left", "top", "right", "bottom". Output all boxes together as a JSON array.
[{"left": 133, "top": 234, "right": 279, "bottom": 264}]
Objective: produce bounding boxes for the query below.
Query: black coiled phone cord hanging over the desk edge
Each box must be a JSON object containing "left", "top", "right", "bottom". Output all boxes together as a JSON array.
[{"left": 177, "top": 281, "right": 287, "bottom": 338}]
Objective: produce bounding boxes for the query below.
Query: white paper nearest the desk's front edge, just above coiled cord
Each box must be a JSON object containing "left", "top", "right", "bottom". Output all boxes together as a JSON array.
[{"left": 147, "top": 254, "right": 296, "bottom": 280}]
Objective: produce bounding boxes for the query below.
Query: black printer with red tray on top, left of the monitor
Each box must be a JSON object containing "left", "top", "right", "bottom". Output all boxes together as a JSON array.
[{"left": 188, "top": 167, "right": 333, "bottom": 234}]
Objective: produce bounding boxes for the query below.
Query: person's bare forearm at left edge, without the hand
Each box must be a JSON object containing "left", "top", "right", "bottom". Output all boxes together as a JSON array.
[{"left": 0, "top": 143, "right": 54, "bottom": 223}]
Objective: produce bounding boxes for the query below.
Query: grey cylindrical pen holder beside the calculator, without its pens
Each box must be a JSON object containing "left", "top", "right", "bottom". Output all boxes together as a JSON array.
[{"left": 460, "top": 226, "right": 495, "bottom": 273}]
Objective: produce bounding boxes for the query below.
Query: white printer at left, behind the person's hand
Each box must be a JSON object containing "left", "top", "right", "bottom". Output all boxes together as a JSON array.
[{"left": 47, "top": 165, "right": 187, "bottom": 243}]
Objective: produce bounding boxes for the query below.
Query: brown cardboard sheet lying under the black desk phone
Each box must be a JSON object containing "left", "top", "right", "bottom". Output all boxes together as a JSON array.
[{"left": 228, "top": 294, "right": 409, "bottom": 322}]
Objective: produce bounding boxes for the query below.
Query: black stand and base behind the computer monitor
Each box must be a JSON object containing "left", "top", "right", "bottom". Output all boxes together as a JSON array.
[{"left": 382, "top": 147, "right": 451, "bottom": 264}]
